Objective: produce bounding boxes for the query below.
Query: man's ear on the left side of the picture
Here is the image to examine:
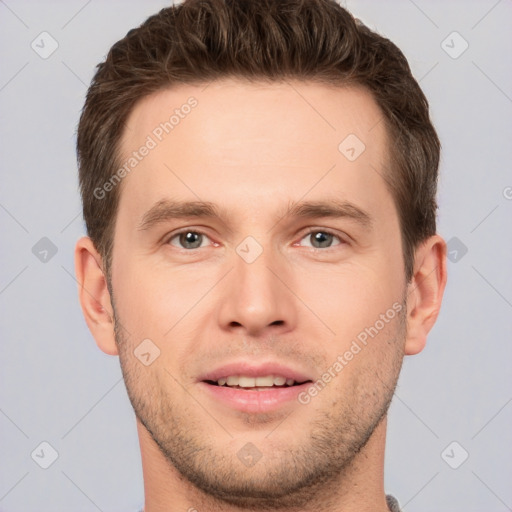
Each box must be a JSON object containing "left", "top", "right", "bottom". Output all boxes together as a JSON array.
[{"left": 75, "top": 236, "right": 118, "bottom": 355}]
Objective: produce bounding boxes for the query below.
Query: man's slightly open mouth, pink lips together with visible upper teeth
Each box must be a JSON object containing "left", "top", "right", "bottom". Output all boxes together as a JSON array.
[{"left": 198, "top": 363, "right": 313, "bottom": 413}]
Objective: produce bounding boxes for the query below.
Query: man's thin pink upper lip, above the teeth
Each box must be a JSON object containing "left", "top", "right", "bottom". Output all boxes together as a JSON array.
[{"left": 197, "top": 361, "right": 312, "bottom": 382}]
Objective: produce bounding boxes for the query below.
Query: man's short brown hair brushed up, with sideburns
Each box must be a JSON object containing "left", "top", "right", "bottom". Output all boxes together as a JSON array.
[{"left": 77, "top": 0, "right": 440, "bottom": 281}]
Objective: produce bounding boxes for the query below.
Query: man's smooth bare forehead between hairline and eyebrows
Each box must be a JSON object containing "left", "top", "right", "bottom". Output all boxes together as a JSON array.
[{"left": 119, "top": 80, "right": 389, "bottom": 222}]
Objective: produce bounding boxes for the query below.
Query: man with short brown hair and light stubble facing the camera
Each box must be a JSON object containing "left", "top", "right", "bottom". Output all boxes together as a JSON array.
[{"left": 75, "top": 0, "right": 446, "bottom": 512}]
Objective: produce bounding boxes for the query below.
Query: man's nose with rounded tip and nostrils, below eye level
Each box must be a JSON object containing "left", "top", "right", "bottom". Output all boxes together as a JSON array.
[{"left": 218, "top": 242, "right": 297, "bottom": 336}]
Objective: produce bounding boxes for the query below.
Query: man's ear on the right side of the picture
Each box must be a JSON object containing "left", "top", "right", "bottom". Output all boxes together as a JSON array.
[{"left": 405, "top": 235, "right": 446, "bottom": 355}]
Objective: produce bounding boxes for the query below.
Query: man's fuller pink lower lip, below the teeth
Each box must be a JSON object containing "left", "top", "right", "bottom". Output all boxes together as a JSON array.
[{"left": 199, "top": 382, "right": 311, "bottom": 413}]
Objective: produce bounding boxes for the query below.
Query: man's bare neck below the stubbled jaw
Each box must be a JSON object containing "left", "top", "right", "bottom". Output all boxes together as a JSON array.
[{"left": 137, "top": 419, "right": 388, "bottom": 512}]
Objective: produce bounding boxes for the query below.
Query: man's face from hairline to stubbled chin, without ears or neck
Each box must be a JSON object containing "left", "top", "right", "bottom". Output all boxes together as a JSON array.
[{"left": 111, "top": 80, "right": 406, "bottom": 508}]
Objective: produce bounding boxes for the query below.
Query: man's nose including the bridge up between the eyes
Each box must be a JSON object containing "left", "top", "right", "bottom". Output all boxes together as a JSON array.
[{"left": 216, "top": 237, "right": 295, "bottom": 334}]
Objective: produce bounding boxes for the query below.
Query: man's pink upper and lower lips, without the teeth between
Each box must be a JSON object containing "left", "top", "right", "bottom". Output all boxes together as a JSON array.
[{"left": 197, "top": 361, "right": 313, "bottom": 413}]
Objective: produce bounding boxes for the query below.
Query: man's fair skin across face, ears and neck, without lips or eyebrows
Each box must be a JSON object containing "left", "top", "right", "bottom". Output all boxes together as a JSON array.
[{"left": 75, "top": 79, "right": 446, "bottom": 512}]
